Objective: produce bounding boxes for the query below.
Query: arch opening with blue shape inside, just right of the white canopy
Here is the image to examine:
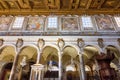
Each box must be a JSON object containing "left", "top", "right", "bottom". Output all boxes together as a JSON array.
[{"left": 40, "top": 46, "right": 59, "bottom": 80}]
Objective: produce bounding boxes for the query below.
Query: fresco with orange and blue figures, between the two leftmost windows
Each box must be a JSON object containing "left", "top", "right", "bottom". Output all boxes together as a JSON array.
[{"left": 26, "top": 17, "right": 44, "bottom": 31}]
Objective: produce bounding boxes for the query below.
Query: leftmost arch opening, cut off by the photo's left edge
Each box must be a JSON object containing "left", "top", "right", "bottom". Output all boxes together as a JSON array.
[{"left": 0, "top": 45, "right": 16, "bottom": 80}]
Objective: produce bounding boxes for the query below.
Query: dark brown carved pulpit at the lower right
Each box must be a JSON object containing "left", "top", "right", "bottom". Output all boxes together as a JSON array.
[{"left": 96, "top": 50, "right": 117, "bottom": 80}]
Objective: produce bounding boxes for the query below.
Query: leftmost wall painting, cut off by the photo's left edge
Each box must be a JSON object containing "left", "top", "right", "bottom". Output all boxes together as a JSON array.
[{"left": 0, "top": 16, "right": 13, "bottom": 31}]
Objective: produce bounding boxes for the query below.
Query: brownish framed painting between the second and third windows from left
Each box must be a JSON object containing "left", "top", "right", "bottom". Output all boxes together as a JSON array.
[{"left": 61, "top": 17, "right": 79, "bottom": 31}]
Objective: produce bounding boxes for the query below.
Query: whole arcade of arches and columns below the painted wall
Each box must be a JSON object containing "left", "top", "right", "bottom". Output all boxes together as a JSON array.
[{"left": 0, "top": 36, "right": 120, "bottom": 80}]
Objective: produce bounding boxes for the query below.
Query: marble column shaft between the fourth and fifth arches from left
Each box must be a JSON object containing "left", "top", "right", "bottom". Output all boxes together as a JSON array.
[{"left": 79, "top": 53, "right": 86, "bottom": 80}]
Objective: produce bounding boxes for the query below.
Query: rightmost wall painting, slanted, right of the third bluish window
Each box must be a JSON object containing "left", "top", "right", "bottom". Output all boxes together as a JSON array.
[{"left": 95, "top": 15, "right": 114, "bottom": 31}]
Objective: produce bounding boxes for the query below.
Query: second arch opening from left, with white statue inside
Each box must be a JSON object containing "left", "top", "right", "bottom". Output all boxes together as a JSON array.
[{"left": 14, "top": 46, "right": 37, "bottom": 80}]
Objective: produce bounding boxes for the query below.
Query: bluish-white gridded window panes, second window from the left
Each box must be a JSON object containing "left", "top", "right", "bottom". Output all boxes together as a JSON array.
[{"left": 47, "top": 17, "right": 58, "bottom": 29}]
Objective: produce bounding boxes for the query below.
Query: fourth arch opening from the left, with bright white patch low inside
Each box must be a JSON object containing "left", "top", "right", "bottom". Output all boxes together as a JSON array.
[{"left": 62, "top": 45, "right": 80, "bottom": 80}]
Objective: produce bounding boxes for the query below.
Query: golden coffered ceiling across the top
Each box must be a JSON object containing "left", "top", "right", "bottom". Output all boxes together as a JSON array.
[{"left": 0, "top": 0, "right": 120, "bottom": 15}]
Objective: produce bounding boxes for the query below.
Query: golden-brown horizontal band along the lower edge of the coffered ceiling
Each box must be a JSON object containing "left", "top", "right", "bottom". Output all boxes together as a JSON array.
[{"left": 0, "top": 9, "right": 120, "bottom": 15}]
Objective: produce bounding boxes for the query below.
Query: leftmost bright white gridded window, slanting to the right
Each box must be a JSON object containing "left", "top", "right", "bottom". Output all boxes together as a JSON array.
[{"left": 12, "top": 17, "right": 25, "bottom": 29}]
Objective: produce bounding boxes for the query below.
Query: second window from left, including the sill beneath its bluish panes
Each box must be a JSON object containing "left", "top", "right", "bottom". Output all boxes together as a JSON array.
[{"left": 46, "top": 16, "right": 58, "bottom": 31}]
